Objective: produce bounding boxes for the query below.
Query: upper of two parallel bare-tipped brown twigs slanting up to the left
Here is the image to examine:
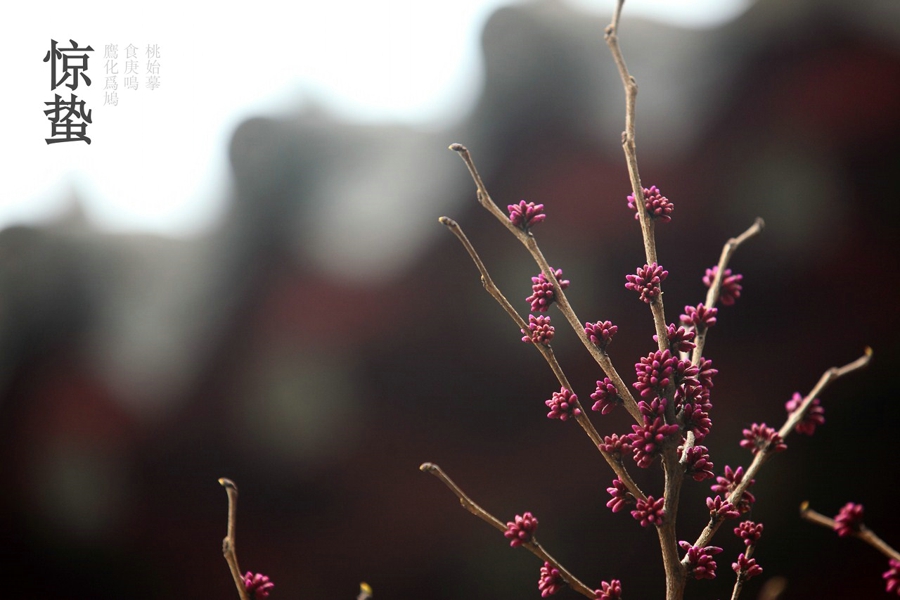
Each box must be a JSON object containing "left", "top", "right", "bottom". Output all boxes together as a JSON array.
[{"left": 441, "top": 144, "right": 644, "bottom": 425}]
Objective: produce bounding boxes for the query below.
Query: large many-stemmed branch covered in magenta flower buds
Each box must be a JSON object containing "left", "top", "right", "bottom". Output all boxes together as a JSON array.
[{"left": 420, "top": 0, "right": 876, "bottom": 600}]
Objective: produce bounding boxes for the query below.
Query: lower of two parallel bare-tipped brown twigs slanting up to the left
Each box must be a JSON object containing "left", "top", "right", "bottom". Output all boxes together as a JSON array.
[{"left": 438, "top": 217, "right": 647, "bottom": 500}]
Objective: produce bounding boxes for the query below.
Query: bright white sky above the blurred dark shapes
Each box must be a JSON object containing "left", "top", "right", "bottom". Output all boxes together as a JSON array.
[{"left": 0, "top": 0, "right": 752, "bottom": 235}]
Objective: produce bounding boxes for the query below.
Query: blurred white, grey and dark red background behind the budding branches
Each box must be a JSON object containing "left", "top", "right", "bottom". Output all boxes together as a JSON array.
[{"left": 0, "top": 0, "right": 900, "bottom": 600}]
